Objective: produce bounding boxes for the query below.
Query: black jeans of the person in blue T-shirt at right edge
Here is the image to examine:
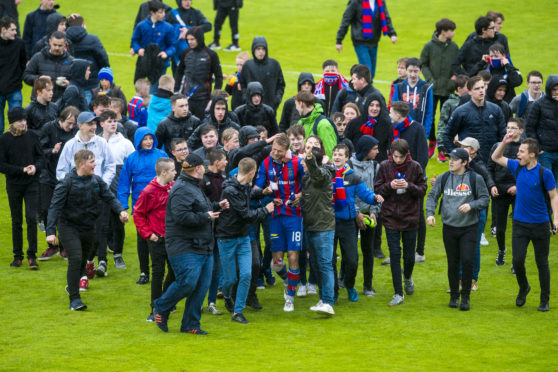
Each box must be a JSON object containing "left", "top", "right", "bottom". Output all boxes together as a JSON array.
[{"left": 512, "top": 220, "right": 550, "bottom": 302}]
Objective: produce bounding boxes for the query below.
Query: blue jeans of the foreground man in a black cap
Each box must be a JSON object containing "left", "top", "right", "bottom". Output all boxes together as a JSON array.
[{"left": 153, "top": 253, "right": 213, "bottom": 332}]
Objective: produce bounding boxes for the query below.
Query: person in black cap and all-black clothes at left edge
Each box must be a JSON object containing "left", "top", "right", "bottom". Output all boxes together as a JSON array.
[{"left": 0, "top": 107, "right": 43, "bottom": 270}]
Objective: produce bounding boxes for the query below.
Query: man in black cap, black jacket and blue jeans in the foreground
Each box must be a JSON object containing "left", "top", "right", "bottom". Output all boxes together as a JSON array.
[{"left": 153, "top": 154, "right": 229, "bottom": 335}]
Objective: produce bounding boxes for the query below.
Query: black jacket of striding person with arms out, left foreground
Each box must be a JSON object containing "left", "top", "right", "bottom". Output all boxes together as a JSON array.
[{"left": 46, "top": 168, "right": 124, "bottom": 235}]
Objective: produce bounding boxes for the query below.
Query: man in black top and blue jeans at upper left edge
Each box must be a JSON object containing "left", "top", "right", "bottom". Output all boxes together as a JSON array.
[{"left": 0, "top": 17, "right": 27, "bottom": 133}]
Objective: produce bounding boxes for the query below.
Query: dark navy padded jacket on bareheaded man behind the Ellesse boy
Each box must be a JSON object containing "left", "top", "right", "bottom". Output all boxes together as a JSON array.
[{"left": 444, "top": 101, "right": 506, "bottom": 162}]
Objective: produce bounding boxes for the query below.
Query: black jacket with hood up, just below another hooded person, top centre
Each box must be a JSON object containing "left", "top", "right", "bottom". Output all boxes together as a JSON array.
[{"left": 234, "top": 83, "right": 279, "bottom": 137}]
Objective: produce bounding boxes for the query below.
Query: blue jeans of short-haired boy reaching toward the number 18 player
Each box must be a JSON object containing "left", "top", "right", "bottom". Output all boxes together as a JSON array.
[{"left": 217, "top": 236, "right": 252, "bottom": 314}]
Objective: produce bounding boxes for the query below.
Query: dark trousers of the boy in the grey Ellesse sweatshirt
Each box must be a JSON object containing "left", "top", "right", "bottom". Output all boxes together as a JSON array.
[{"left": 442, "top": 223, "right": 479, "bottom": 298}]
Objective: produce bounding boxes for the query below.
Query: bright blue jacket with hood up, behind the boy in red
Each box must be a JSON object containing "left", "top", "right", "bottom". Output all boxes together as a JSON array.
[{"left": 117, "top": 127, "right": 168, "bottom": 211}]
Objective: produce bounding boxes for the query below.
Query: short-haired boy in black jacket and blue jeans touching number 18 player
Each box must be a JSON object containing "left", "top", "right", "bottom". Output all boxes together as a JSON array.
[{"left": 215, "top": 158, "right": 274, "bottom": 324}]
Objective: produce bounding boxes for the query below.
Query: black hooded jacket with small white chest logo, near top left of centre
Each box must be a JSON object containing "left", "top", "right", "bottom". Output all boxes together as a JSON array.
[{"left": 175, "top": 26, "right": 223, "bottom": 102}]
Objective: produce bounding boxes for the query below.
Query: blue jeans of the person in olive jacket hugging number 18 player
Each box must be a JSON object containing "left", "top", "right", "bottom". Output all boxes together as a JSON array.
[{"left": 305, "top": 230, "right": 335, "bottom": 306}]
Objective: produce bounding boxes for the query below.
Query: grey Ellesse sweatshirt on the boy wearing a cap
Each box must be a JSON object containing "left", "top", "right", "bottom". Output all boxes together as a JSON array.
[{"left": 426, "top": 171, "right": 489, "bottom": 227}]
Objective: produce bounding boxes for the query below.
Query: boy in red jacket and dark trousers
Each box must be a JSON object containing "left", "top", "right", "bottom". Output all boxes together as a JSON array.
[{"left": 134, "top": 158, "right": 176, "bottom": 322}]
